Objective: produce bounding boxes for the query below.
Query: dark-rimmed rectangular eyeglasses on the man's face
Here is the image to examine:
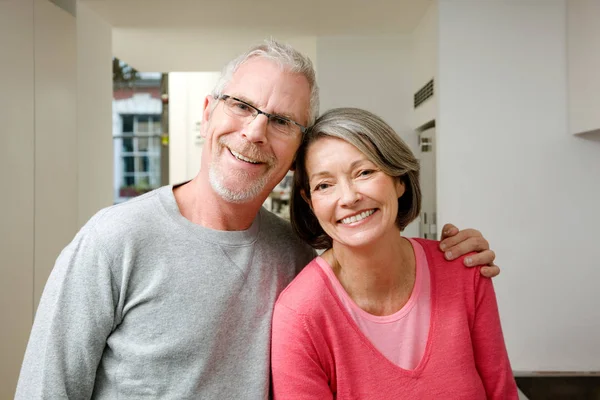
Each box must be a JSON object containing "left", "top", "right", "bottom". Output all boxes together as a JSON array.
[{"left": 219, "top": 94, "right": 308, "bottom": 137}]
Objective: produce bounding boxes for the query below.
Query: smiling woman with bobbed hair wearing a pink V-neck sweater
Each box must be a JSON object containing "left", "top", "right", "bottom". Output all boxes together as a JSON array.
[{"left": 272, "top": 108, "right": 518, "bottom": 400}]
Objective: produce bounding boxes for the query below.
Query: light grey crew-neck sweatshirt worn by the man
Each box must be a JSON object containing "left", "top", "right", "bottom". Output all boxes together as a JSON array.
[{"left": 16, "top": 186, "right": 315, "bottom": 400}]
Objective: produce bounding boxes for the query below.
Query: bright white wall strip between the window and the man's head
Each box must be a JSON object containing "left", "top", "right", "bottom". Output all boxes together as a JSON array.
[{"left": 169, "top": 72, "right": 220, "bottom": 184}]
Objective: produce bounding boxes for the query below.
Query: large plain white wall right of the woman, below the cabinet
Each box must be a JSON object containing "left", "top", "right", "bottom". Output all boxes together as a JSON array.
[{"left": 438, "top": 0, "right": 600, "bottom": 371}]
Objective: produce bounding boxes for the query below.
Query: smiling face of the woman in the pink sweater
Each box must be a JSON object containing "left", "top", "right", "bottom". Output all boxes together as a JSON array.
[{"left": 305, "top": 137, "right": 405, "bottom": 247}]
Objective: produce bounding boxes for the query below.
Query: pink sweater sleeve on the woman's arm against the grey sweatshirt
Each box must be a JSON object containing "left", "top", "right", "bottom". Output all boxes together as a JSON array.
[{"left": 271, "top": 303, "right": 333, "bottom": 400}]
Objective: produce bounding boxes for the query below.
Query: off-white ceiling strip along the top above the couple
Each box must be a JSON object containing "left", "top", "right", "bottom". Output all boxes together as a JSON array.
[{"left": 80, "top": 0, "right": 431, "bottom": 36}]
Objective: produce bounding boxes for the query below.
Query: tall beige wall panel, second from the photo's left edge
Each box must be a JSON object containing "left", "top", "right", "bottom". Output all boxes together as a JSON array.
[{"left": 34, "top": 0, "right": 78, "bottom": 308}]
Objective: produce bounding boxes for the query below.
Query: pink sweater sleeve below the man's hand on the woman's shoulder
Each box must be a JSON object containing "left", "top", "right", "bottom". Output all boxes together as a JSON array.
[{"left": 472, "top": 272, "right": 519, "bottom": 400}]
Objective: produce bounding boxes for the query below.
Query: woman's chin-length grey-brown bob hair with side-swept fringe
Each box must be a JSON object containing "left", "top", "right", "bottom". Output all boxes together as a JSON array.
[{"left": 290, "top": 108, "right": 421, "bottom": 249}]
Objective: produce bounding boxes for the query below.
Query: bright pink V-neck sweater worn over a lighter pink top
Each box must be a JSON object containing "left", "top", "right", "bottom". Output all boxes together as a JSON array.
[{"left": 271, "top": 240, "right": 518, "bottom": 400}]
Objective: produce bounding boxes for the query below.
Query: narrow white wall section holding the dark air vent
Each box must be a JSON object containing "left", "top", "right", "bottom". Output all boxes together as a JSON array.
[{"left": 410, "top": 1, "right": 438, "bottom": 129}]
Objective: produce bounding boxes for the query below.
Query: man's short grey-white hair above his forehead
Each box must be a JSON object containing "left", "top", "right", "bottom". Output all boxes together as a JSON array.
[{"left": 212, "top": 39, "right": 319, "bottom": 126}]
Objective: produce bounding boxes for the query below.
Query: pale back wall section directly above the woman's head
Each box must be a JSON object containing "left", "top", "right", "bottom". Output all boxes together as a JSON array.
[{"left": 317, "top": 35, "right": 419, "bottom": 236}]
